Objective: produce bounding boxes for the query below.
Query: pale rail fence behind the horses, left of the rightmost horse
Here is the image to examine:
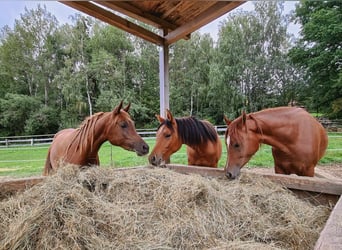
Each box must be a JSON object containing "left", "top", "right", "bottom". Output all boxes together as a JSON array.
[{"left": 0, "top": 126, "right": 226, "bottom": 148}]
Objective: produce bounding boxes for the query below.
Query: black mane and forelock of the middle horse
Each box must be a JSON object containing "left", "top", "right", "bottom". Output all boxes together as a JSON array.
[{"left": 166, "top": 116, "right": 217, "bottom": 146}]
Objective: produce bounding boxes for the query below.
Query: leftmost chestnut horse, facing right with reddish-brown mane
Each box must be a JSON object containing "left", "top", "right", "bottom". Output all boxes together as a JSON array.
[{"left": 43, "top": 101, "right": 149, "bottom": 175}]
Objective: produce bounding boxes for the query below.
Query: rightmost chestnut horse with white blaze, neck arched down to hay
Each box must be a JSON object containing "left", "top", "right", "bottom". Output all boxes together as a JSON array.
[{"left": 224, "top": 107, "right": 328, "bottom": 179}]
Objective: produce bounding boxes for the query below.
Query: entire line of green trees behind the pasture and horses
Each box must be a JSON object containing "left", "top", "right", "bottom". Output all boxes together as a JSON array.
[{"left": 0, "top": 1, "right": 342, "bottom": 136}]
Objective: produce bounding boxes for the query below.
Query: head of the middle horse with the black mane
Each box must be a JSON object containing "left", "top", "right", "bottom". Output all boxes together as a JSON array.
[{"left": 148, "top": 110, "right": 182, "bottom": 166}]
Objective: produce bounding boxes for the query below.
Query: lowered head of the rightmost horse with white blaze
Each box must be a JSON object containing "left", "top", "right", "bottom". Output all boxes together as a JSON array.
[{"left": 224, "top": 112, "right": 259, "bottom": 179}]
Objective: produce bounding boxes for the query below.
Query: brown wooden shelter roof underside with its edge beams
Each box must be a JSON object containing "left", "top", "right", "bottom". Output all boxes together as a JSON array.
[{"left": 60, "top": 0, "right": 244, "bottom": 45}]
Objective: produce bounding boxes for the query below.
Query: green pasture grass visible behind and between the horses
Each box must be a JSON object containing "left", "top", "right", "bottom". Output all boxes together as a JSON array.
[{"left": 0, "top": 133, "right": 342, "bottom": 177}]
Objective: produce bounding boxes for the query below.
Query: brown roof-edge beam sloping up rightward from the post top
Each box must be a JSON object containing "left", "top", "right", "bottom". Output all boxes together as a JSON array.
[{"left": 164, "top": 1, "right": 244, "bottom": 44}]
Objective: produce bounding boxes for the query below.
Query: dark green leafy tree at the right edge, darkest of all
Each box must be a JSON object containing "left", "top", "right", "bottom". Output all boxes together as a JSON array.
[{"left": 289, "top": 1, "right": 342, "bottom": 118}]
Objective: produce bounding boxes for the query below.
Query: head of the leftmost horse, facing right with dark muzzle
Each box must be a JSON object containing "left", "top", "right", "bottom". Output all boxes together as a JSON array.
[{"left": 106, "top": 101, "right": 149, "bottom": 156}]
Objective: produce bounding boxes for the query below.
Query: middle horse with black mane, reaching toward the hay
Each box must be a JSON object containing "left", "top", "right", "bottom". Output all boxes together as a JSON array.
[{"left": 149, "top": 110, "right": 222, "bottom": 168}]
